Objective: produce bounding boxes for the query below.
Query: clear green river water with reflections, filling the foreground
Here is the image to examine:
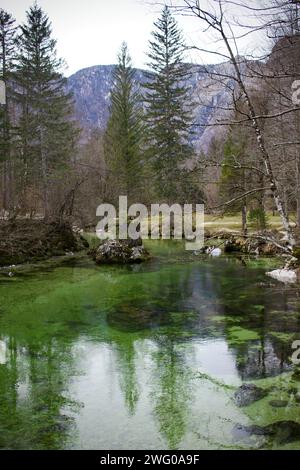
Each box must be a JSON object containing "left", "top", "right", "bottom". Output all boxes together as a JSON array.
[{"left": 0, "top": 242, "right": 300, "bottom": 449}]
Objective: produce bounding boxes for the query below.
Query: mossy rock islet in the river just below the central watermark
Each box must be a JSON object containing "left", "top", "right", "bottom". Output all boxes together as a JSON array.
[{"left": 92, "top": 239, "right": 149, "bottom": 264}]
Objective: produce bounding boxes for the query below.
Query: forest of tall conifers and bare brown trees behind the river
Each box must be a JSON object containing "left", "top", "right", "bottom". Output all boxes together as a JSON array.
[{"left": 0, "top": 1, "right": 300, "bottom": 248}]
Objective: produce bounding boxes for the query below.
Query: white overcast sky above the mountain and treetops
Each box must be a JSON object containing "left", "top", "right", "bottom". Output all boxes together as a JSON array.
[{"left": 1, "top": 0, "right": 268, "bottom": 75}]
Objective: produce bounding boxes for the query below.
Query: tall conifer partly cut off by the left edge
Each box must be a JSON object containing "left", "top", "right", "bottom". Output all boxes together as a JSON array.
[{"left": 0, "top": 9, "right": 17, "bottom": 210}]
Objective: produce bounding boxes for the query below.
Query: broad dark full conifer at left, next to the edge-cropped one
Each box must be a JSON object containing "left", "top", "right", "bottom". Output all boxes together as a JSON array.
[{"left": 16, "top": 3, "right": 77, "bottom": 217}]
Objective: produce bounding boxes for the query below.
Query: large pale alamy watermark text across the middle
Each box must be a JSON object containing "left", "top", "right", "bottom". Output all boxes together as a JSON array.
[{"left": 96, "top": 196, "right": 204, "bottom": 250}]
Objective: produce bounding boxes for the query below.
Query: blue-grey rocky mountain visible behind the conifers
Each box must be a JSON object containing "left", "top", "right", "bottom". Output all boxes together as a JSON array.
[{"left": 67, "top": 63, "right": 232, "bottom": 152}]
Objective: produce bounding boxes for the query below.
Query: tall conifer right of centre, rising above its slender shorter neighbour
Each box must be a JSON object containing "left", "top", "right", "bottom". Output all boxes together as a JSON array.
[{"left": 145, "top": 6, "right": 193, "bottom": 199}]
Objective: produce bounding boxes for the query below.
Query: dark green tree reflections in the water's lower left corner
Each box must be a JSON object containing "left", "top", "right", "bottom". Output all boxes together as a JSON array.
[{"left": 0, "top": 336, "right": 77, "bottom": 449}]
